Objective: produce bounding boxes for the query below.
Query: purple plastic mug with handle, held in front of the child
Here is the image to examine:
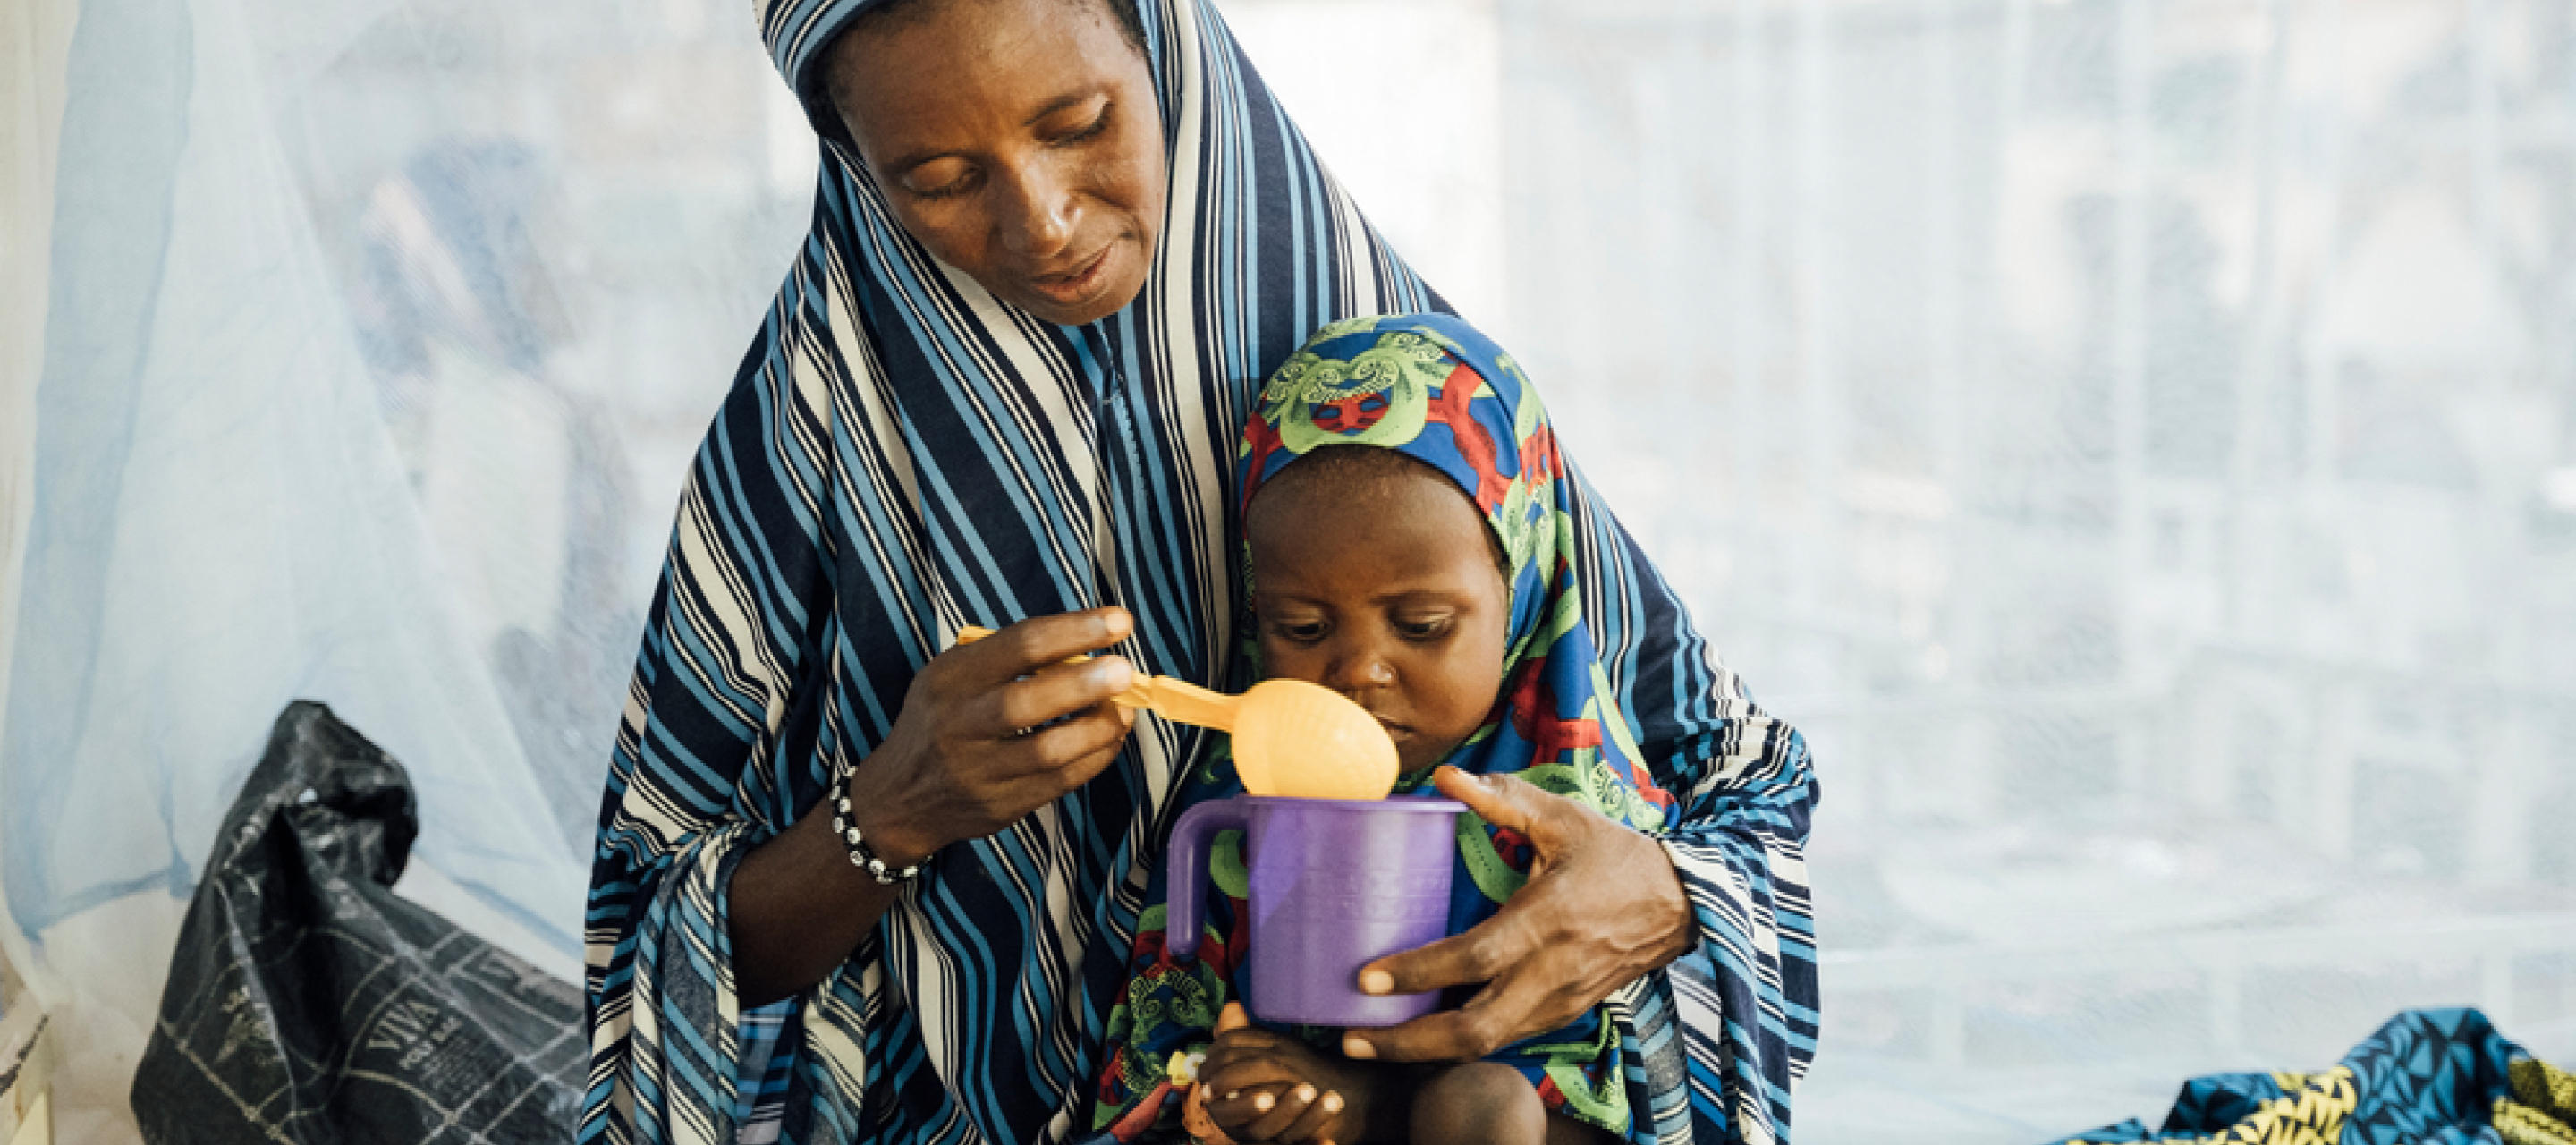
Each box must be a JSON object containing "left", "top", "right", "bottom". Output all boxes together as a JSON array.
[{"left": 1165, "top": 794, "right": 1466, "bottom": 1026}]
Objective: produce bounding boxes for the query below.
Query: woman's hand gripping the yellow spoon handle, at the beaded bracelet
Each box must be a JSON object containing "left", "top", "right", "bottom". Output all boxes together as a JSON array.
[{"left": 850, "top": 608, "right": 1136, "bottom": 867}]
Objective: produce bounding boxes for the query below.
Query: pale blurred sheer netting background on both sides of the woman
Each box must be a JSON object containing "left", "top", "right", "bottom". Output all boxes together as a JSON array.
[{"left": 0, "top": 0, "right": 2576, "bottom": 1142}]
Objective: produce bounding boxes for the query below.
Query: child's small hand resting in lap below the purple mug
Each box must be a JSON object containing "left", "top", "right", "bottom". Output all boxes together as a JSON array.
[{"left": 1198, "top": 1003, "right": 1376, "bottom": 1145}]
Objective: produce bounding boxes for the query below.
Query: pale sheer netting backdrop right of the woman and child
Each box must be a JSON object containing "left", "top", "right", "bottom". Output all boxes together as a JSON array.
[{"left": 1432, "top": 0, "right": 2576, "bottom": 1140}]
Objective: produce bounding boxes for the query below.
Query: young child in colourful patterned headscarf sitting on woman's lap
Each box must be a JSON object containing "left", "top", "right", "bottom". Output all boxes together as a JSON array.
[{"left": 1097, "top": 315, "right": 1672, "bottom": 1145}]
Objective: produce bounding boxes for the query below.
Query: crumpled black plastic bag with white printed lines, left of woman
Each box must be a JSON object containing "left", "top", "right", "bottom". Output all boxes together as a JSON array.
[{"left": 134, "top": 701, "right": 588, "bottom": 1145}]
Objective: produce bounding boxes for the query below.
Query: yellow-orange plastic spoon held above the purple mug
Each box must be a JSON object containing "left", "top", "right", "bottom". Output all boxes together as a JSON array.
[{"left": 958, "top": 624, "right": 1396, "bottom": 800}]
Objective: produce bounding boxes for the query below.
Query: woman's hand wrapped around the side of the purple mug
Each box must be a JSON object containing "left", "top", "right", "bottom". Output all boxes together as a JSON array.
[{"left": 1342, "top": 766, "right": 1695, "bottom": 1063}]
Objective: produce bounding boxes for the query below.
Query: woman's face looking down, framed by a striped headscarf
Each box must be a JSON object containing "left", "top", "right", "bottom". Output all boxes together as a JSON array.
[{"left": 826, "top": 0, "right": 1167, "bottom": 325}]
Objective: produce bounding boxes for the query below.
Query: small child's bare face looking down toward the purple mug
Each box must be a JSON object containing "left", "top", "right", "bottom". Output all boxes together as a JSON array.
[{"left": 1244, "top": 464, "right": 1513, "bottom": 771}]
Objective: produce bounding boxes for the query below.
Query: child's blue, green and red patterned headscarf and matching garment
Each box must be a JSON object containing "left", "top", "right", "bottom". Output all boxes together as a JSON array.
[{"left": 1095, "top": 315, "right": 1680, "bottom": 1142}]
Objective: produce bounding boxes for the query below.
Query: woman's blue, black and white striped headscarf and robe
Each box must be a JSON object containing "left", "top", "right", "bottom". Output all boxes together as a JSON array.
[{"left": 580, "top": 0, "right": 1816, "bottom": 1145}]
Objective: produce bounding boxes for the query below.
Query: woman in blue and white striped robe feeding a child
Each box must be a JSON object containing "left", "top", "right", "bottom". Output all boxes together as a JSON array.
[{"left": 582, "top": 0, "right": 1814, "bottom": 1142}]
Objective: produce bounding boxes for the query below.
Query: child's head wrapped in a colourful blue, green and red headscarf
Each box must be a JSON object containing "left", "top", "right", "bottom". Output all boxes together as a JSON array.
[{"left": 1234, "top": 315, "right": 1672, "bottom": 830}]
